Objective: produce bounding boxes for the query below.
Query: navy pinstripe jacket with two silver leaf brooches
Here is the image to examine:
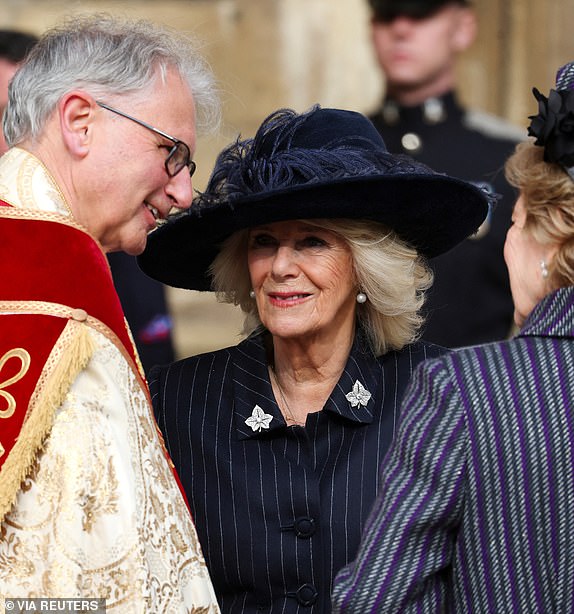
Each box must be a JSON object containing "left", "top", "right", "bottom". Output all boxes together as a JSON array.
[{"left": 150, "top": 335, "right": 443, "bottom": 614}]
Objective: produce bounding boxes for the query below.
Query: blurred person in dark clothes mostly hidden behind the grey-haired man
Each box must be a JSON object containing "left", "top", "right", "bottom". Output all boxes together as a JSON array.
[{"left": 0, "top": 30, "right": 175, "bottom": 373}]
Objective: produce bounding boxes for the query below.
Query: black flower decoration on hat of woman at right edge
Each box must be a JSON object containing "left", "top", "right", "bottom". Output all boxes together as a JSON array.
[{"left": 528, "top": 62, "right": 574, "bottom": 181}]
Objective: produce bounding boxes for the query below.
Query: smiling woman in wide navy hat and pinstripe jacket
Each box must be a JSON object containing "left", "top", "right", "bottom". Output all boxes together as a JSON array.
[{"left": 140, "top": 107, "right": 488, "bottom": 613}]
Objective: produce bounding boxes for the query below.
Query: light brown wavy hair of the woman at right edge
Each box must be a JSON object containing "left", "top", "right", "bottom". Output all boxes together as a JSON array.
[{"left": 505, "top": 141, "right": 574, "bottom": 288}]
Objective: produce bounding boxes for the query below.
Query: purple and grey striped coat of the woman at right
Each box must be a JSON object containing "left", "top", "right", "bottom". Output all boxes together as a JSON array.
[{"left": 333, "top": 287, "right": 574, "bottom": 614}]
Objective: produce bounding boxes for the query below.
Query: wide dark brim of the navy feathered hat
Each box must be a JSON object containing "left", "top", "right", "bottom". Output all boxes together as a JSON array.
[{"left": 138, "top": 174, "right": 488, "bottom": 291}]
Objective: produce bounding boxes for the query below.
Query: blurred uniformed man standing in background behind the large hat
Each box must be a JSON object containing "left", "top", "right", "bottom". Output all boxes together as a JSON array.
[{"left": 369, "top": 0, "right": 524, "bottom": 347}]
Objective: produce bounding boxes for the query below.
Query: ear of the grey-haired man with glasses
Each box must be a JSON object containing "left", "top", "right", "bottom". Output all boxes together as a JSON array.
[{"left": 58, "top": 91, "right": 96, "bottom": 157}]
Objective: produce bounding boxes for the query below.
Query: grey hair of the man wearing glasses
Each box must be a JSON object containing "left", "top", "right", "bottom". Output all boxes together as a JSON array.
[{"left": 4, "top": 14, "right": 220, "bottom": 146}]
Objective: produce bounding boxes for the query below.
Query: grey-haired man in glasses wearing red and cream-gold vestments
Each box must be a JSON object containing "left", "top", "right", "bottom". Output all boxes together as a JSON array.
[{"left": 0, "top": 16, "right": 218, "bottom": 612}]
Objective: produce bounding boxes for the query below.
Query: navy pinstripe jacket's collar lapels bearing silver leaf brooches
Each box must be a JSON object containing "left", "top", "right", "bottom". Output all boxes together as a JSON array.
[{"left": 232, "top": 334, "right": 383, "bottom": 439}]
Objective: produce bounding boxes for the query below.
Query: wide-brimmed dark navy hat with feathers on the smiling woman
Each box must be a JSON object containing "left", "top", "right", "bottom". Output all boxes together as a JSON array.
[{"left": 138, "top": 106, "right": 489, "bottom": 290}]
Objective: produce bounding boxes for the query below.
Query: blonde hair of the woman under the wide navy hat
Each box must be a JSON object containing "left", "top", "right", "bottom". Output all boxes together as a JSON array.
[{"left": 210, "top": 219, "right": 432, "bottom": 356}]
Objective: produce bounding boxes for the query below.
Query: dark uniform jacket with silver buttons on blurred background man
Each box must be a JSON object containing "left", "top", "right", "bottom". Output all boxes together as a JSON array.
[{"left": 371, "top": 93, "right": 526, "bottom": 347}]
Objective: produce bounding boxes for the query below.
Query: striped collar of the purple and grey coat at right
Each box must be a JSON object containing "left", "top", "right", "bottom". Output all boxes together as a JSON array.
[{"left": 518, "top": 286, "right": 574, "bottom": 337}]
